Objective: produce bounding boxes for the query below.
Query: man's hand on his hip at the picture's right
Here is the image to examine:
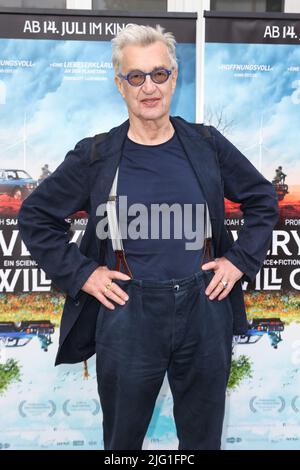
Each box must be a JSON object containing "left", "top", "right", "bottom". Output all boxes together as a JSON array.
[{"left": 201, "top": 256, "right": 244, "bottom": 300}]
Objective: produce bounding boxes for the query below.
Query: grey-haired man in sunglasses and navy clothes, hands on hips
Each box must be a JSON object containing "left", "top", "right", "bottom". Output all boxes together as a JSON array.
[{"left": 19, "top": 25, "right": 278, "bottom": 450}]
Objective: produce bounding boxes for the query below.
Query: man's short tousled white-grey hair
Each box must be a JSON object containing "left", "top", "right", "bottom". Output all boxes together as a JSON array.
[{"left": 111, "top": 24, "right": 178, "bottom": 75}]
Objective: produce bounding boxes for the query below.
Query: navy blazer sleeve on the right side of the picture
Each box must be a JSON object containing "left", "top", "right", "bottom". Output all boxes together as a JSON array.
[{"left": 210, "top": 126, "right": 279, "bottom": 282}]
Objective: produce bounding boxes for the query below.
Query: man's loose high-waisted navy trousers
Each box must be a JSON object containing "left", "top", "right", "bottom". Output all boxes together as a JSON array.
[{"left": 95, "top": 270, "right": 233, "bottom": 450}]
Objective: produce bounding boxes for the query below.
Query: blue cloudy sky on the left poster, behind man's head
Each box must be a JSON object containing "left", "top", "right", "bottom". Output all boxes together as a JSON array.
[{"left": 0, "top": 39, "right": 195, "bottom": 177}]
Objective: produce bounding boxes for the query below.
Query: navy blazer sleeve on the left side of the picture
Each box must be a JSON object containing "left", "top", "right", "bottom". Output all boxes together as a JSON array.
[{"left": 18, "top": 138, "right": 98, "bottom": 299}]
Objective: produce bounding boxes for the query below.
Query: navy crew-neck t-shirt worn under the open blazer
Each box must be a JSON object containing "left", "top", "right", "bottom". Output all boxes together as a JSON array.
[{"left": 105, "top": 133, "right": 205, "bottom": 280}]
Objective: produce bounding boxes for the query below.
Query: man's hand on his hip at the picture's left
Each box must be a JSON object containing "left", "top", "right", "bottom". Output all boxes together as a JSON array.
[{"left": 81, "top": 266, "right": 131, "bottom": 310}]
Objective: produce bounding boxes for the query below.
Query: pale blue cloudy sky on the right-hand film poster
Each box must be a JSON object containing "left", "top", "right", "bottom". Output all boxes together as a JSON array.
[{"left": 204, "top": 43, "right": 300, "bottom": 184}]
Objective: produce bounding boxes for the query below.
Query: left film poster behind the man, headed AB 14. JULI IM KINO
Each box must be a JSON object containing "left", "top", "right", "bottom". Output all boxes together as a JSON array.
[{"left": 0, "top": 6, "right": 196, "bottom": 449}]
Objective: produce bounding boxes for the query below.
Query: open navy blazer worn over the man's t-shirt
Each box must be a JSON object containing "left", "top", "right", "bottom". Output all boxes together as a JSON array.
[{"left": 19, "top": 117, "right": 278, "bottom": 365}]
